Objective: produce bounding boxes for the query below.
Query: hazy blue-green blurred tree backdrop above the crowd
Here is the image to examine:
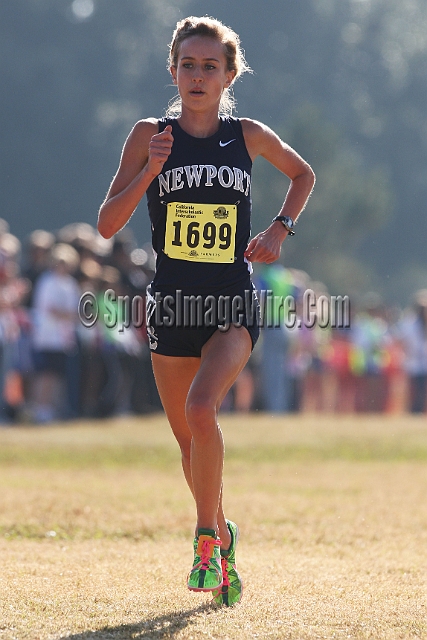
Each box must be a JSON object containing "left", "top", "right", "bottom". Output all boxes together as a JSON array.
[{"left": 0, "top": 0, "right": 427, "bottom": 303}]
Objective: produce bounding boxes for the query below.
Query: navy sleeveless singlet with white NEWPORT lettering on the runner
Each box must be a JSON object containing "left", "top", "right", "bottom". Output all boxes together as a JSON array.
[{"left": 147, "top": 118, "right": 252, "bottom": 295}]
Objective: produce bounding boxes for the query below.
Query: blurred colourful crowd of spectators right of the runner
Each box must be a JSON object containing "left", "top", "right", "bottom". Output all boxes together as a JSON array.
[{"left": 251, "top": 265, "right": 427, "bottom": 413}]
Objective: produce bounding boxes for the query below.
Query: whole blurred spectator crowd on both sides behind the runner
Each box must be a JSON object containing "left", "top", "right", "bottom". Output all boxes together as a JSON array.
[{"left": 0, "top": 219, "right": 427, "bottom": 425}]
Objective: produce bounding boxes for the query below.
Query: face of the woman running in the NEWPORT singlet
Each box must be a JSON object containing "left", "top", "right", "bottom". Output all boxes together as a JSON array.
[{"left": 171, "top": 36, "right": 235, "bottom": 110}]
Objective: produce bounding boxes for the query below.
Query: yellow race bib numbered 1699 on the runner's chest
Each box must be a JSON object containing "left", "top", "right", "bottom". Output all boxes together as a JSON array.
[{"left": 164, "top": 202, "right": 237, "bottom": 262}]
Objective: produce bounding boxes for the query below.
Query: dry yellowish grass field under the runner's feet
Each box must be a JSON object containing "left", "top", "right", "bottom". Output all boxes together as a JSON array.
[{"left": 0, "top": 415, "right": 427, "bottom": 640}]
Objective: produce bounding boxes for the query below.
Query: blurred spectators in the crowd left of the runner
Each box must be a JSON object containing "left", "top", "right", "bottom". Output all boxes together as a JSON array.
[{"left": 0, "top": 221, "right": 161, "bottom": 424}]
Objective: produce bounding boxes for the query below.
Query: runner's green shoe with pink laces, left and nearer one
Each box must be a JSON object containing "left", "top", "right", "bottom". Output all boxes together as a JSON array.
[{"left": 187, "top": 529, "right": 222, "bottom": 591}]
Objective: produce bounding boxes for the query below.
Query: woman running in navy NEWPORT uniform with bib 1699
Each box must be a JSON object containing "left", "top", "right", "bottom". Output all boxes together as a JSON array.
[{"left": 98, "top": 17, "right": 314, "bottom": 606}]
